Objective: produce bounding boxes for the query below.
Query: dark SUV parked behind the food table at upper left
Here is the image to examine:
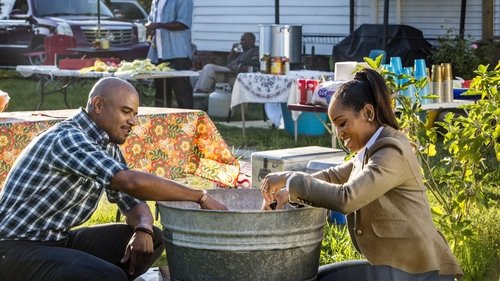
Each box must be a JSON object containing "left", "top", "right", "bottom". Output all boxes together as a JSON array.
[{"left": 0, "top": 0, "right": 149, "bottom": 65}]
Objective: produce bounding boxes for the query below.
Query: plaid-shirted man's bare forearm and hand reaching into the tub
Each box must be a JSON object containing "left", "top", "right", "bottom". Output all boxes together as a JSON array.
[{"left": 111, "top": 167, "right": 226, "bottom": 210}]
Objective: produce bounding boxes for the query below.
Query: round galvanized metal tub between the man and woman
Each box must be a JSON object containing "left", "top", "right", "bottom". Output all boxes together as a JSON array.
[{"left": 158, "top": 189, "right": 326, "bottom": 281}]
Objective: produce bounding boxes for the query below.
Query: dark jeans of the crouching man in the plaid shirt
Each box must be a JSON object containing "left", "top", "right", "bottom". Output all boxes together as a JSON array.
[{"left": 0, "top": 224, "right": 164, "bottom": 281}]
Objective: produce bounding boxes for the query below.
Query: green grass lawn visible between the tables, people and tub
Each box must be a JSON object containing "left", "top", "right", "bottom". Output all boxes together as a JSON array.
[{"left": 0, "top": 71, "right": 500, "bottom": 281}]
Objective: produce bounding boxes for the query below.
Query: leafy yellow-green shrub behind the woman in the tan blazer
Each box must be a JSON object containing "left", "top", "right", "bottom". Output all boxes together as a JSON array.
[{"left": 365, "top": 58, "right": 500, "bottom": 280}]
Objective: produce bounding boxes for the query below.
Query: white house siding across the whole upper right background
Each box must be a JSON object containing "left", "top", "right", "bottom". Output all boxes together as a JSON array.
[{"left": 192, "top": 0, "right": 500, "bottom": 55}]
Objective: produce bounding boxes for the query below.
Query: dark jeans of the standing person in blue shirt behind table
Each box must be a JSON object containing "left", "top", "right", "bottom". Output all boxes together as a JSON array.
[{"left": 155, "top": 58, "right": 193, "bottom": 109}]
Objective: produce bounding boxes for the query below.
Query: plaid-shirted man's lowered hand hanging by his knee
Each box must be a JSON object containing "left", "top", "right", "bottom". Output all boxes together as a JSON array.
[{"left": 121, "top": 231, "right": 154, "bottom": 275}]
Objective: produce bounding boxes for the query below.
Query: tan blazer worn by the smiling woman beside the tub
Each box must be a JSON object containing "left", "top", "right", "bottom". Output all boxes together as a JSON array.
[{"left": 289, "top": 127, "right": 463, "bottom": 277}]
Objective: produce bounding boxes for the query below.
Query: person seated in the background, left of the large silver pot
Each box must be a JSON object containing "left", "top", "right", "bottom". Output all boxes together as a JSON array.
[{"left": 194, "top": 32, "right": 259, "bottom": 93}]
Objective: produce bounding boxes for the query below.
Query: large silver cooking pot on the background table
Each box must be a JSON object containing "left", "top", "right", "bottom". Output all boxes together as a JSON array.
[{"left": 259, "top": 24, "right": 302, "bottom": 63}]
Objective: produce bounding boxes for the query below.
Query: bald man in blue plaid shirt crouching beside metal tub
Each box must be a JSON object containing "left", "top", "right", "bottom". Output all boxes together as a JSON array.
[{"left": 0, "top": 78, "right": 226, "bottom": 281}]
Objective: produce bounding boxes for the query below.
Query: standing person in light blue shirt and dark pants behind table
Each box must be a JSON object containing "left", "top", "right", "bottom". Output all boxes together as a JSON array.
[{"left": 146, "top": 0, "right": 193, "bottom": 108}]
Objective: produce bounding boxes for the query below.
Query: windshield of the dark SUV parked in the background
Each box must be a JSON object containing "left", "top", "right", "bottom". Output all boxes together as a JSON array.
[{"left": 33, "top": 0, "right": 113, "bottom": 17}]
